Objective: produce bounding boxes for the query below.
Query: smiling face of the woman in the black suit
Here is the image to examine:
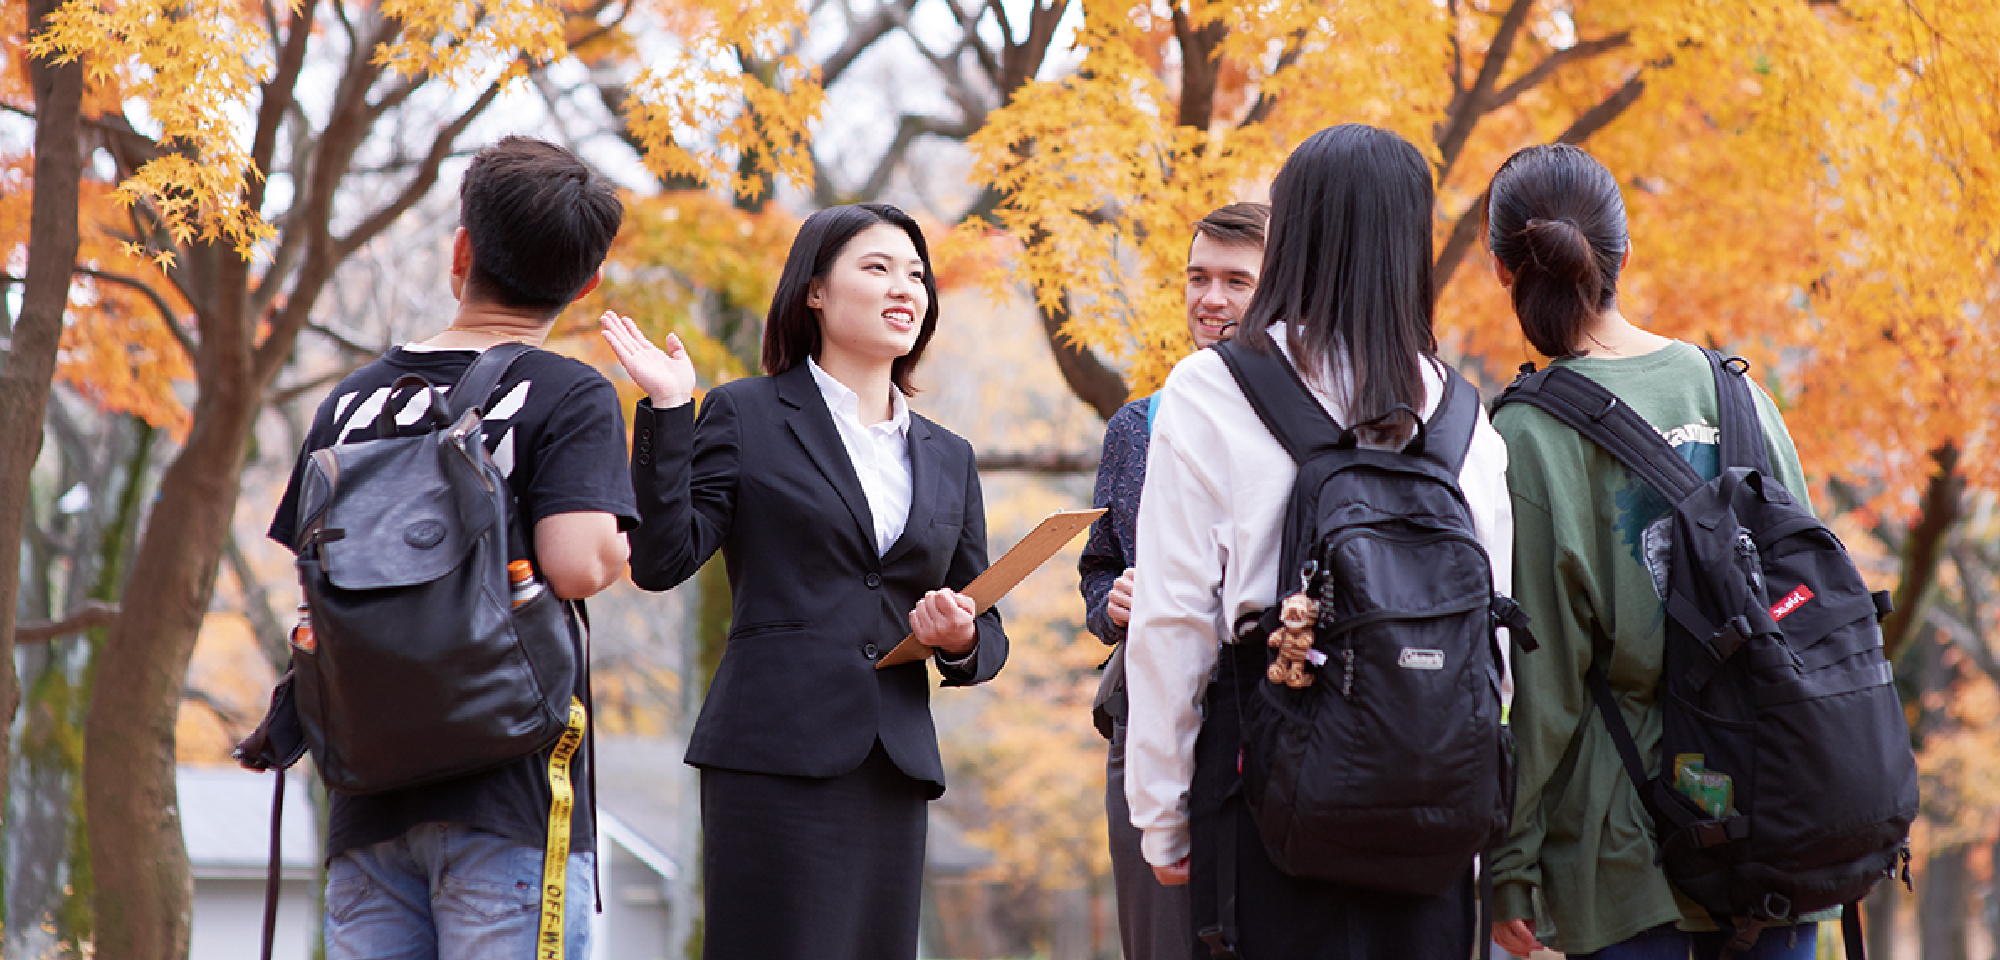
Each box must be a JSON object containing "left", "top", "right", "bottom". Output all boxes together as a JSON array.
[{"left": 806, "top": 224, "right": 930, "bottom": 366}]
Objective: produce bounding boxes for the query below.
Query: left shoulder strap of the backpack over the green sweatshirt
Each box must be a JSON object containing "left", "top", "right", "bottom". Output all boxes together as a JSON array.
[{"left": 1494, "top": 366, "right": 1702, "bottom": 504}]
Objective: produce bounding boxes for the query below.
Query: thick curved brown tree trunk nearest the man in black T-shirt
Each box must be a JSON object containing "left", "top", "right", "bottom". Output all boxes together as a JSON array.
[{"left": 84, "top": 340, "right": 262, "bottom": 960}]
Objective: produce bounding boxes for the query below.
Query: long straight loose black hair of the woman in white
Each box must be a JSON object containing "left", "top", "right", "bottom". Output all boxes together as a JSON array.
[{"left": 1236, "top": 124, "right": 1438, "bottom": 442}]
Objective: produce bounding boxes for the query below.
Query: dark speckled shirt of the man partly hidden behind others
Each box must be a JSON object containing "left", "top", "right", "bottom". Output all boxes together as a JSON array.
[{"left": 1076, "top": 396, "right": 1152, "bottom": 644}]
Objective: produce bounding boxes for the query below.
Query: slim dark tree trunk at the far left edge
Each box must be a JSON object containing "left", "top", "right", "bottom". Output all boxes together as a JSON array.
[{"left": 0, "top": 0, "right": 84, "bottom": 840}]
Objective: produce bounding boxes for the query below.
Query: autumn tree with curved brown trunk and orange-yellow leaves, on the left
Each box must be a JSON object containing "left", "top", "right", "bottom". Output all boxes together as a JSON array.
[{"left": 4, "top": 0, "right": 816, "bottom": 958}]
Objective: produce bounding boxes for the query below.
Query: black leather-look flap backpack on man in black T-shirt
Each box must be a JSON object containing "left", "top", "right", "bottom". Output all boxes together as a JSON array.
[{"left": 270, "top": 344, "right": 580, "bottom": 794}]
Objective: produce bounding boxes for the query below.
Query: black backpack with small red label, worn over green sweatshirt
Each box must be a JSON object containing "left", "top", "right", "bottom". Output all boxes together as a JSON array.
[{"left": 1494, "top": 350, "right": 1918, "bottom": 958}]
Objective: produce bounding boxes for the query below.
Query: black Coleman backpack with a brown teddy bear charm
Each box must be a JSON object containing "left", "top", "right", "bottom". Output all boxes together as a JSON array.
[{"left": 1190, "top": 342, "right": 1534, "bottom": 912}]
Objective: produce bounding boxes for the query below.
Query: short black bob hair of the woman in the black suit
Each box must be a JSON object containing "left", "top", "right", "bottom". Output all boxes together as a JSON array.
[{"left": 764, "top": 204, "right": 938, "bottom": 396}]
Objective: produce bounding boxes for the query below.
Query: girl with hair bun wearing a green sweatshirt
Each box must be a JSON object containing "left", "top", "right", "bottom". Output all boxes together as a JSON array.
[{"left": 1486, "top": 144, "right": 1820, "bottom": 960}]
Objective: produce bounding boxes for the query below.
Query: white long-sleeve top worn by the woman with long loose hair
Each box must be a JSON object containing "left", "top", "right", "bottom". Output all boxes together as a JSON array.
[{"left": 1126, "top": 332, "right": 1514, "bottom": 866}]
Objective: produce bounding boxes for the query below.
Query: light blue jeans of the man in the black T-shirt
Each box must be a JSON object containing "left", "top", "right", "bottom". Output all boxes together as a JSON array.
[{"left": 326, "top": 824, "right": 596, "bottom": 960}]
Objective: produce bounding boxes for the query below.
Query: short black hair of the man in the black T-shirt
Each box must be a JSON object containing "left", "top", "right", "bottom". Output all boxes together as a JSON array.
[{"left": 458, "top": 136, "right": 624, "bottom": 316}]
